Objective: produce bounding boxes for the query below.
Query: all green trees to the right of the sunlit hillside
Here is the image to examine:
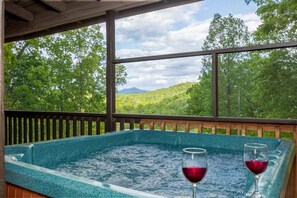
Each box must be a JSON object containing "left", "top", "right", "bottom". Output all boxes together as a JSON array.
[{"left": 187, "top": 0, "right": 297, "bottom": 119}]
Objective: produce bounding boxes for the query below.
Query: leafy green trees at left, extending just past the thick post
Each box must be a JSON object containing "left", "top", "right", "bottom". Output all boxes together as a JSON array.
[{"left": 5, "top": 25, "right": 127, "bottom": 112}]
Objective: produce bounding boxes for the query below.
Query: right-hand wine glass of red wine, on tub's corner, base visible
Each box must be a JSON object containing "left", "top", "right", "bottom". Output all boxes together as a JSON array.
[{"left": 244, "top": 143, "right": 268, "bottom": 198}]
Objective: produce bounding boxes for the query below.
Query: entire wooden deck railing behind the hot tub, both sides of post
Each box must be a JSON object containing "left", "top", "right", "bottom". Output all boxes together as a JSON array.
[{"left": 5, "top": 111, "right": 297, "bottom": 198}]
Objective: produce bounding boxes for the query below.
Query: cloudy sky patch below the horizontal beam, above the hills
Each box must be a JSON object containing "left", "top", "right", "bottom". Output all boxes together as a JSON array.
[{"left": 118, "top": 57, "right": 202, "bottom": 90}]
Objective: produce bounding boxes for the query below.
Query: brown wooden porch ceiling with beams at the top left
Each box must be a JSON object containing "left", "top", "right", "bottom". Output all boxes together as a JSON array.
[{"left": 4, "top": 0, "right": 197, "bottom": 42}]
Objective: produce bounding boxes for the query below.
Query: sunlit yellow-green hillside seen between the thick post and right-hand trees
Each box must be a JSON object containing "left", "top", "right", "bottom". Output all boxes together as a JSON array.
[{"left": 116, "top": 82, "right": 193, "bottom": 115}]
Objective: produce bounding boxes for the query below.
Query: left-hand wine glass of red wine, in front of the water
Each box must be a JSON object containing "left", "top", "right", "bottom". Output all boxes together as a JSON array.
[{"left": 182, "top": 148, "right": 207, "bottom": 198}]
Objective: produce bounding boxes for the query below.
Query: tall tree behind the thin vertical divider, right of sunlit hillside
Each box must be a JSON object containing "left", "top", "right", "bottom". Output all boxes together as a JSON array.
[{"left": 187, "top": 14, "right": 250, "bottom": 116}]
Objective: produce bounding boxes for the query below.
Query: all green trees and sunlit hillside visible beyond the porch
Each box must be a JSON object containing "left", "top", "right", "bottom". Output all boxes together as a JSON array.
[{"left": 4, "top": 0, "right": 297, "bottom": 119}]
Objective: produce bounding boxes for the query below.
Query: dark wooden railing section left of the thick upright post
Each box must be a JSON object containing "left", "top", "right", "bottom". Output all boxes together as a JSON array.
[{"left": 5, "top": 111, "right": 106, "bottom": 145}]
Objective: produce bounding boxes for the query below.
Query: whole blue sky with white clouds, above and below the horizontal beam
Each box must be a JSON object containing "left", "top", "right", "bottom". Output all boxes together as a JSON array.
[{"left": 103, "top": 0, "right": 261, "bottom": 90}]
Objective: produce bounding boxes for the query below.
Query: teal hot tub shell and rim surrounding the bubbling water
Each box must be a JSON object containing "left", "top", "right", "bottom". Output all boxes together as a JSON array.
[{"left": 5, "top": 130, "right": 295, "bottom": 198}]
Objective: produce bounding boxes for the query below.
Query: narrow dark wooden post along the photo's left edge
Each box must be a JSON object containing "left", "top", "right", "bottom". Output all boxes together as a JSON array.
[{"left": 0, "top": 0, "right": 5, "bottom": 197}]
